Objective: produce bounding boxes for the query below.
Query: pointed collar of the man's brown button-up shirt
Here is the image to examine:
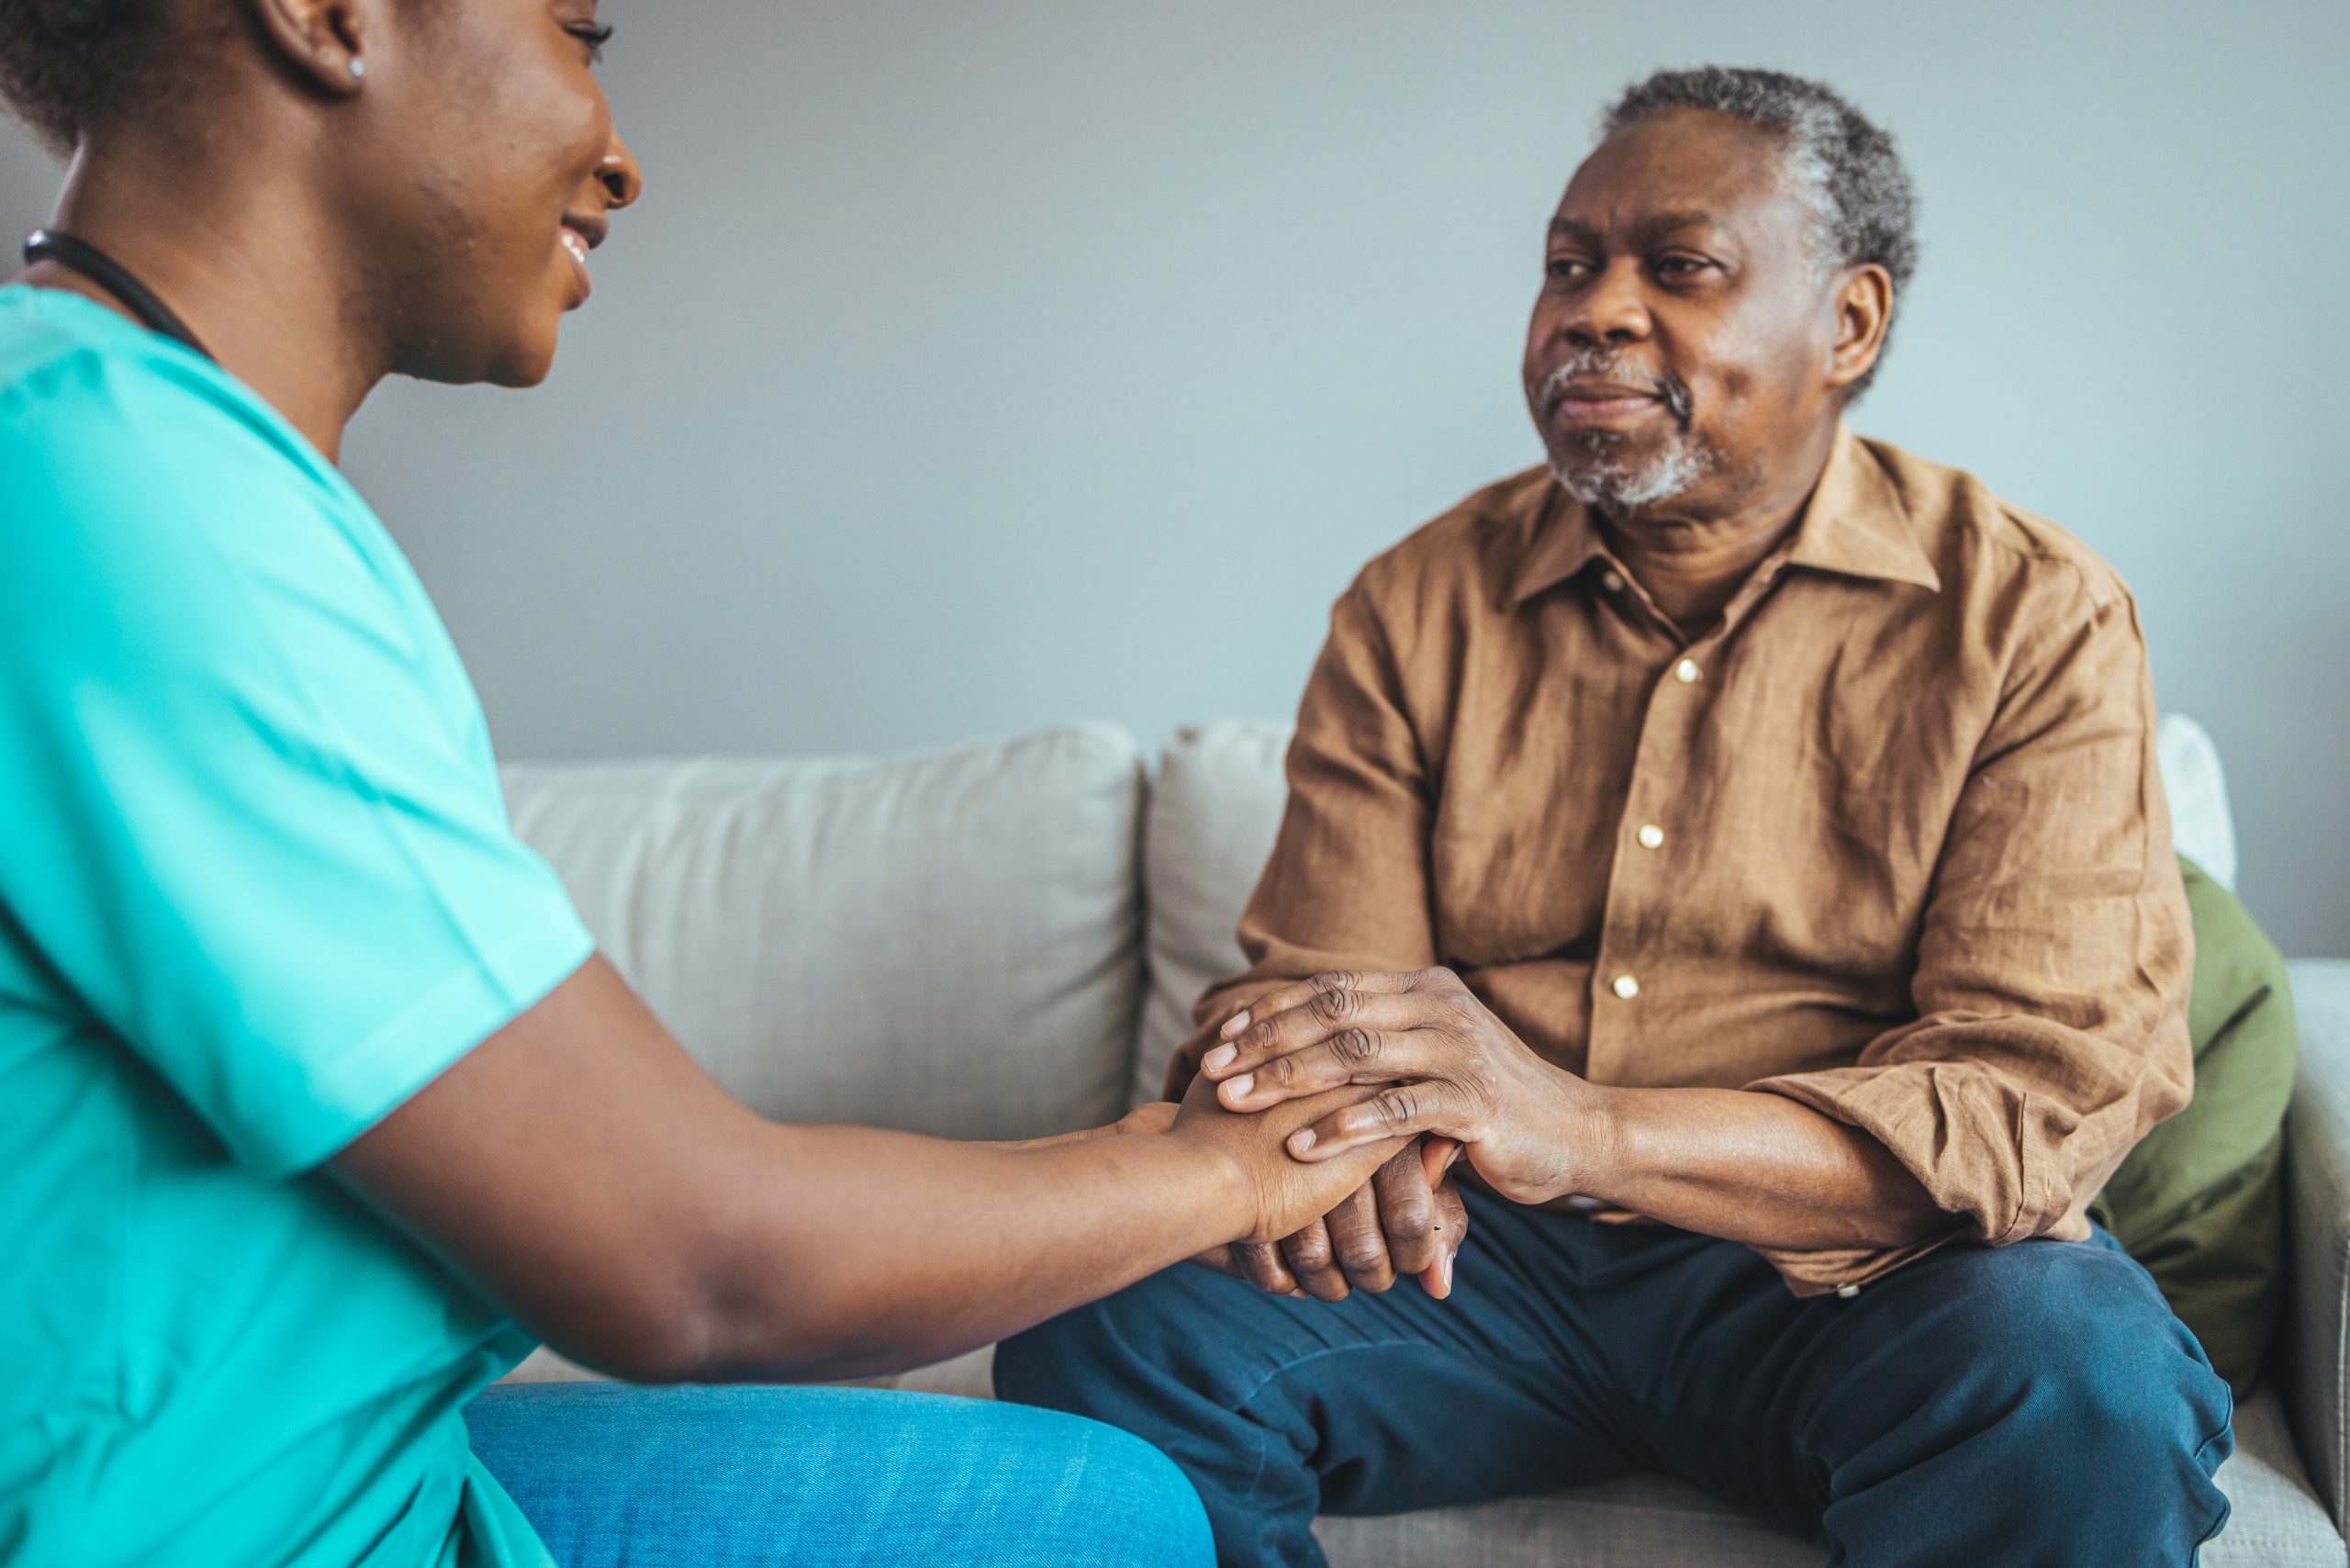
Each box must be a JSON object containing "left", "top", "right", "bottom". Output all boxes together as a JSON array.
[{"left": 1511, "top": 420, "right": 1942, "bottom": 604}]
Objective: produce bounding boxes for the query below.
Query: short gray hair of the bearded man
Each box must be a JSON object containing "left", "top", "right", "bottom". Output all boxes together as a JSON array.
[{"left": 1600, "top": 66, "right": 1918, "bottom": 398}]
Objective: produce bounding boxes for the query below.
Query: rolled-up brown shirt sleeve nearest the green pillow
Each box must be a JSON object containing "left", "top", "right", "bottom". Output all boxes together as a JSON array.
[{"left": 1751, "top": 586, "right": 2195, "bottom": 1295}]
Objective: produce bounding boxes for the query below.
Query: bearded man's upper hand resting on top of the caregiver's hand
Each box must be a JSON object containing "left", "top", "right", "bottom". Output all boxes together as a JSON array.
[{"left": 1201, "top": 969, "right": 1595, "bottom": 1204}]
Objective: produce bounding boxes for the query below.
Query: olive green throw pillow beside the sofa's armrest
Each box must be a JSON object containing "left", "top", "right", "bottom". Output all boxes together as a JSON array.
[{"left": 2089, "top": 856, "right": 2296, "bottom": 1394}]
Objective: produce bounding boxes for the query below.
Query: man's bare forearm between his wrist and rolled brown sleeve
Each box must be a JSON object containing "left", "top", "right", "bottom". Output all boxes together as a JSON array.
[{"left": 1561, "top": 1081, "right": 1957, "bottom": 1250}]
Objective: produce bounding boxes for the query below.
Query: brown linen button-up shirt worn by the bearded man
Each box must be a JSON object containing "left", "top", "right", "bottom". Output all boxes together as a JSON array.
[{"left": 1172, "top": 431, "right": 2192, "bottom": 1295}]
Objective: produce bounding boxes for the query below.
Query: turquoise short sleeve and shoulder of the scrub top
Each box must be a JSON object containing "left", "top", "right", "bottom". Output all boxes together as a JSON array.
[{"left": 0, "top": 301, "right": 592, "bottom": 1175}]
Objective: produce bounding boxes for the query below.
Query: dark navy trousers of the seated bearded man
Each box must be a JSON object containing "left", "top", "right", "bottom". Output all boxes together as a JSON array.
[{"left": 996, "top": 1194, "right": 2232, "bottom": 1568}]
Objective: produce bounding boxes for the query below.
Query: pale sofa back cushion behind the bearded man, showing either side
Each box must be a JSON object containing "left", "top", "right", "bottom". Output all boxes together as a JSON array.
[{"left": 1133, "top": 714, "right": 2235, "bottom": 1100}]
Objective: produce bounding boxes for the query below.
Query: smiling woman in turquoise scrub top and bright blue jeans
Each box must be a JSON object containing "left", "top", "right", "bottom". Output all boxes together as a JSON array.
[{"left": 0, "top": 0, "right": 1392, "bottom": 1568}]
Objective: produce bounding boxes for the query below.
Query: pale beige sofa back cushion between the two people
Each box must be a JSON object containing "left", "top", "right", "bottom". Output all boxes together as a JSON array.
[{"left": 505, "top": 726, "right": 1142, "bottom": 1137}]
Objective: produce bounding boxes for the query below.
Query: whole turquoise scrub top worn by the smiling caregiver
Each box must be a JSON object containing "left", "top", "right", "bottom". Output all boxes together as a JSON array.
[{"left": 0, "top": 285, "right": 592, "bottom": 1568}]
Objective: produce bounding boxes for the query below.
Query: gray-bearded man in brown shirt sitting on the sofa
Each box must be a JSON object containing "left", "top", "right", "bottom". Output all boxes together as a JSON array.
[{"left": 996, "top": 68, "right": 2230, "bottom": 1568}]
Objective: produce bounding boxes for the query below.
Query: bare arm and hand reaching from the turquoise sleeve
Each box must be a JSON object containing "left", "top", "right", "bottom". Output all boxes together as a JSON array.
[{"left": 331, "top": 959, "right": 1401, "bottom": 1383}]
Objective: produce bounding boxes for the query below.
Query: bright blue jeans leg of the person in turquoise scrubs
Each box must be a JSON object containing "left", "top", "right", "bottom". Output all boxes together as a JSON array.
[{"left": 465, "top": 1383, "right": 1210, "bottom": 1568}]
